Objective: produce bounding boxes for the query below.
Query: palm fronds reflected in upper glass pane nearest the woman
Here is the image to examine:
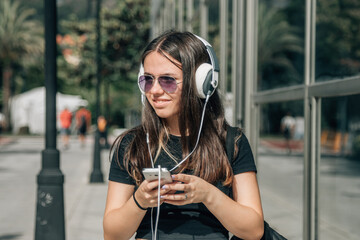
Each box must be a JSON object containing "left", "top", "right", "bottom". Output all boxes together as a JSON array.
[{"left": 258, "top": 2, "right": 304, "bottom": 89}]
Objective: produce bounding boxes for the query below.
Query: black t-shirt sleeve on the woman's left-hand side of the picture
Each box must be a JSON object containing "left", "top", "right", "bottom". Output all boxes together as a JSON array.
[{"left": 109, "top": 133, "right": 135, "bottom": 185}]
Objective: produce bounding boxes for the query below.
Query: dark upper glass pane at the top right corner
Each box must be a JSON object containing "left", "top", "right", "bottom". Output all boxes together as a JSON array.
[{"left": 315, "top": 0, "right": 360, "bottom": 81}]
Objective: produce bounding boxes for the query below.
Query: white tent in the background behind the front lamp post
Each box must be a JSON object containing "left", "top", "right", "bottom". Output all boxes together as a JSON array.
[{"left": 10, "top": 87, "right": 88, "bottom": 134}]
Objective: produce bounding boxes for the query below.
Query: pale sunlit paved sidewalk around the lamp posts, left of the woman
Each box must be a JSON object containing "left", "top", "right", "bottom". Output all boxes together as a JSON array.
[{"left": 0, "top": 136, "right": 110, "bottom": 240}]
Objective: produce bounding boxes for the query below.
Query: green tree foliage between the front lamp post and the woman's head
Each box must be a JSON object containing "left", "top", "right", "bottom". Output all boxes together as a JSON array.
[{"left": 58, "top": 0, "right": 150, "bottom": 125}]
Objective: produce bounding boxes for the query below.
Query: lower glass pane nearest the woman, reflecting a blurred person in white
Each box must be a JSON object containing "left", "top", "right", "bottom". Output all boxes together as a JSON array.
[{"left": 257, "top": 101, "right": 304, "bottom": 240}]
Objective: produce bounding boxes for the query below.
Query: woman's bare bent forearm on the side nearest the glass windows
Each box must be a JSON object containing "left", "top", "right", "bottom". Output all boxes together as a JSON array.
[{"left": 204, "top": 185, "right": 264, "bottom": 239}]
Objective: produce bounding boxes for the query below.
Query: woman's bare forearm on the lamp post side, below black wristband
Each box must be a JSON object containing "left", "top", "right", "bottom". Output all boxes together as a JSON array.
[{"left": 103, "top": 197, "right": 146, "bottom": 240}]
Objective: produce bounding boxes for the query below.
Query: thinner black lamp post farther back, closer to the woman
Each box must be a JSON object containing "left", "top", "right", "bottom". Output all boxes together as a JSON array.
[{"left": 90, "top": 0, "right": 104, "bottom": 183}]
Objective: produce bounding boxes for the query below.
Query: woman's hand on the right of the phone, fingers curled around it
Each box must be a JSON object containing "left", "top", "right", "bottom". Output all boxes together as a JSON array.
[{"left": 161, "top": 174, "right": 213, "bottom": 205}]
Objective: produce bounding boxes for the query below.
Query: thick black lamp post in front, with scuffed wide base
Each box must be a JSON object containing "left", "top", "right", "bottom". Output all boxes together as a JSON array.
[{"left": 35, "top": 0, "right": 65, "bottom": 240}]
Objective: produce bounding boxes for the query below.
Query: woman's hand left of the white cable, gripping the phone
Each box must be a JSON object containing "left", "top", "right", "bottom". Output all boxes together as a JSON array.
[{"left": 134, "top": 180, "right": 169, "bottom": 208}]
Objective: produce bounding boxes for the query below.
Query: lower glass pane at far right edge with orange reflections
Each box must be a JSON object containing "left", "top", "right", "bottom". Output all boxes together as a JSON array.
[{"left": 319, "top": 95, "right": 360, "bottom": 240}]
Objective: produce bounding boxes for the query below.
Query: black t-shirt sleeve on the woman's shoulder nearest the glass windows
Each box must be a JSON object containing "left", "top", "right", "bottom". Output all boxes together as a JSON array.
[{"left": 231, "top": 133, "right": 257, "bottom": 175}]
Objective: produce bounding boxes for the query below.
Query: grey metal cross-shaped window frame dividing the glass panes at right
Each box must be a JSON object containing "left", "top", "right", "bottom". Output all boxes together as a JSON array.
[{"left": 250, "top": 0, "right": 360, "bottom": 240}]
